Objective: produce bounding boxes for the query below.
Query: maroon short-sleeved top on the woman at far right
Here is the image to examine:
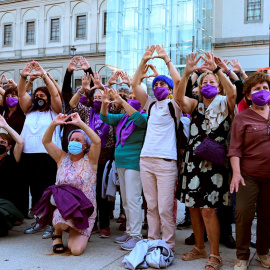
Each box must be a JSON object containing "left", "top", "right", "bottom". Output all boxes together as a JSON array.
[{"left": 228, "top": 109, "right": 270, "bottom": 177}]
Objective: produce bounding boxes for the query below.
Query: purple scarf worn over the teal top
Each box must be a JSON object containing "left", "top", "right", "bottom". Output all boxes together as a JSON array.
[{"left": 115, "top": 99, "right": 142, "bottom": 147}]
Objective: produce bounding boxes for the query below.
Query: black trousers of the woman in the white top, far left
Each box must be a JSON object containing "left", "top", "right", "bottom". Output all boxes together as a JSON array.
[{"left": 21, "top": 153, "right": 57, "bottom": 212}]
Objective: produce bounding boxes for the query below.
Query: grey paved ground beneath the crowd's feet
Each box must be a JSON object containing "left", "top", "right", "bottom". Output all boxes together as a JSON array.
[{"left": 0, "top": 196, "right": 264, "bottom": 270}]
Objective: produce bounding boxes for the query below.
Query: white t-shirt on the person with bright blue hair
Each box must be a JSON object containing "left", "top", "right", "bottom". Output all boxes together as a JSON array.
[{"left": 140, "top": 96, "right": 182, "bottom": 160}]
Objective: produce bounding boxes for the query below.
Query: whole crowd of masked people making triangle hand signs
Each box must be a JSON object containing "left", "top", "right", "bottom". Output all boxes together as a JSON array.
[{"left": 0, "top": 45, "right": 270, "bottom": 270}]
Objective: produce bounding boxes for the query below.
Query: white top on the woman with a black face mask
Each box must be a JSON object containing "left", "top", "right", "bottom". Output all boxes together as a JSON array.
[{"left": 21, "top": 110, "right": 62, "bottom": 153}]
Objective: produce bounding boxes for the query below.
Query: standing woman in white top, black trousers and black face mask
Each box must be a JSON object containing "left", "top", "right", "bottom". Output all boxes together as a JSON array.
[{"left": 18, "top": 61, "right": 62, "bottom": 238}]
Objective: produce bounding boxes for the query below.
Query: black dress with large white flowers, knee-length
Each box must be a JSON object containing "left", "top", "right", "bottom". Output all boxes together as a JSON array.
[{"left": 177, "top": 102, "right": 231, "bottom": 208}]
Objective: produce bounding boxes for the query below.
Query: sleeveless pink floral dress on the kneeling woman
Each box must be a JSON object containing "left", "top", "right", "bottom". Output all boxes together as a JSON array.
[{"left": 53, "top": 154, "right": 97, "bottom": 237}]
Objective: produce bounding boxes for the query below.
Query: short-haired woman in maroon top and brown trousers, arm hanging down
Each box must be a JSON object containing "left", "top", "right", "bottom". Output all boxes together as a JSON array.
[{"left": 228, "top": 72, "right": 270, "bottom": 270}]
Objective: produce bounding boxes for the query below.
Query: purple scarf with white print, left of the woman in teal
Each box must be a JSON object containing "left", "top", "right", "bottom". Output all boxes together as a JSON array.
[{"left": 89, "top": 101, "right": 110, "bottom": 148}]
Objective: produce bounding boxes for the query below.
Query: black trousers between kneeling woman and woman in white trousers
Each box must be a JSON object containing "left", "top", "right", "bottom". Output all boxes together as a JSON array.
[{"left": 96, "top": 164, "right": 112, "bottom": 229}]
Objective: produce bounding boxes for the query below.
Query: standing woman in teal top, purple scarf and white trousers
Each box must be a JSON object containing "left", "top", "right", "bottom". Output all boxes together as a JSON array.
[{"left": 100, "top": 89, "right": 147, "bottom": 250}]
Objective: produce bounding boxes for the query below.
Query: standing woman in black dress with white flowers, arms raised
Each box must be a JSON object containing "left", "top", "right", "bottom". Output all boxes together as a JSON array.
[{"left": 176, "top": 52, "right": 236, "bottom": 269}]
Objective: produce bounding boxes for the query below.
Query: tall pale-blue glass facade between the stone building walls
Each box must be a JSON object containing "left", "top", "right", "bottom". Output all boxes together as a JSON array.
[{"left": 106, "top": 0, "right": 213, "bottom": 90}]
